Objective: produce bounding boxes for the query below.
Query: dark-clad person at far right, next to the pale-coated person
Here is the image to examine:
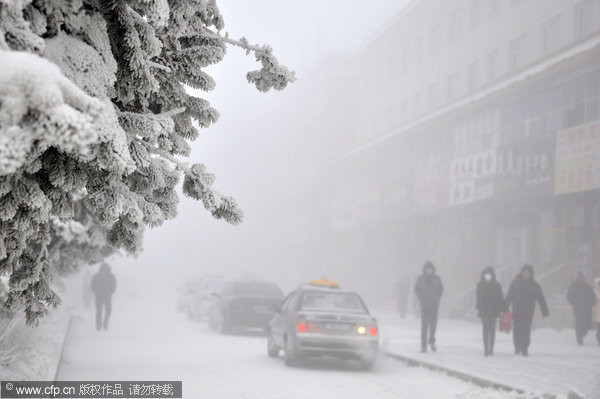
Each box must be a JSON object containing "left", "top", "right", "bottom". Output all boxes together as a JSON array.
[{"left": 567, "top": 272, "right": 596, "bottom": 345}]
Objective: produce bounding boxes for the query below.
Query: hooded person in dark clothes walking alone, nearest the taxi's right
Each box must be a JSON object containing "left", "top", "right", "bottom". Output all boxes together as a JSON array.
[{"left": 415, "top": 261, "right": 444, "bottom": 352}]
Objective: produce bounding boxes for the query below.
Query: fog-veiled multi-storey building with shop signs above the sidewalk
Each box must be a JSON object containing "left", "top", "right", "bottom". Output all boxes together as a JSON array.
[{"left": 324, "top": 0, "right": 600, "bottom": 323}]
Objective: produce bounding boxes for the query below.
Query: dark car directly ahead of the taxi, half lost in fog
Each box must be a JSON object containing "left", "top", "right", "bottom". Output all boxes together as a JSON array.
[{"left": 209, "top": 280, "right": 283, "bottom": 333}]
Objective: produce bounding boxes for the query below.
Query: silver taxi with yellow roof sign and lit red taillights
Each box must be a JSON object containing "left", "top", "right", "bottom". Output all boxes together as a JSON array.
[{"left": 267, "top": 280, "right": 379, "bottom": 369}]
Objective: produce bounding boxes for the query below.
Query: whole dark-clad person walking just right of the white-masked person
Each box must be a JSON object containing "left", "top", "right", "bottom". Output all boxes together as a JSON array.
[{"left": 506, "top": 265, "right": 549, "bottom": 356}]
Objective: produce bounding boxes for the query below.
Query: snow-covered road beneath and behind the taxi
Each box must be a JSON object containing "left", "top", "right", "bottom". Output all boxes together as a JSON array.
[{"left": 58, "top": 298, "right": 508, "bottom": 399}]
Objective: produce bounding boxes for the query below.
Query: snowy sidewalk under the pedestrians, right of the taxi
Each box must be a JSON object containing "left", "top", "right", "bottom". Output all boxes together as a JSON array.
[{"left": 378, "top": 313, "right": 600, "bottom": 399}]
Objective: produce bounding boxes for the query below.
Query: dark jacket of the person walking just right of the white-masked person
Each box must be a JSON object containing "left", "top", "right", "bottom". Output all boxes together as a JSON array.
[{"left": 506, "top": 265, "right": 549, "bottom": 319}]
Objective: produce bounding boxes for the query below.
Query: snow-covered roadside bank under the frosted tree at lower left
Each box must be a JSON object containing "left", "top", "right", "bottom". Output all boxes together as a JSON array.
[{"left": 0, "top": 308, "right": 70, "bottom": 381}]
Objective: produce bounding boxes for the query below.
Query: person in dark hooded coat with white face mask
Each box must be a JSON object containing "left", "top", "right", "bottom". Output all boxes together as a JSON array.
[{"left": 475, "top": 266, "right": 506, "bottom": 356}]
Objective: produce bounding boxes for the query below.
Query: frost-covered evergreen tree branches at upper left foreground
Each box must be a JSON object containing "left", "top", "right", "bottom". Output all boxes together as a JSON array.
[{"left": 0, "top": 0, "right": 295, "bottom": 325}]
